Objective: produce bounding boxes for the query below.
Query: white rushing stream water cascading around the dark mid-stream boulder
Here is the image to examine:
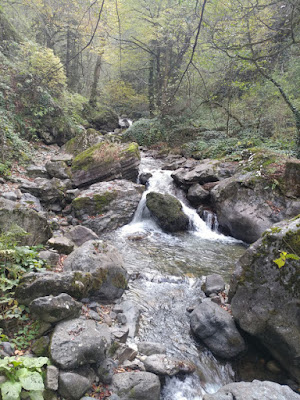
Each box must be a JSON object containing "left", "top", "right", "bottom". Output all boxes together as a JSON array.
[{"left": 103, "top": 157, "right": 245, "bottom": 400}]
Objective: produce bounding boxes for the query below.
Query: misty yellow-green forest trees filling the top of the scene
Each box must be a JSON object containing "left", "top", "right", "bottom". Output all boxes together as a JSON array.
[{"left": 0, "top": 0, "right": 300, "bottom": 156}]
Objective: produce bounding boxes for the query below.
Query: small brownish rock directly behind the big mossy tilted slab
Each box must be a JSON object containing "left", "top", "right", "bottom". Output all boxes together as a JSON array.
[{"left": 63, "top": 128, "right": 104, "bottom": 156}]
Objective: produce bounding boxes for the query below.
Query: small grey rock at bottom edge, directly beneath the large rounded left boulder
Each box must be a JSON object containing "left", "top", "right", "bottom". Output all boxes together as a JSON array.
[{"left": 58, "top": 372, "right": 92, "bottom": 400}]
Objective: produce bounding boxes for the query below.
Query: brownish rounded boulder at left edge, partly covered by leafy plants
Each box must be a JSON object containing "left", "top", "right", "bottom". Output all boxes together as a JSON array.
[{"left": 0, "top": 205, "right": 52, "bottom": 246}]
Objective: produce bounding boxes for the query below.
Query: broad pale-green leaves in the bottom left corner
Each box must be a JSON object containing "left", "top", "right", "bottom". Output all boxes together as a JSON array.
[{"left": 0, "top": 356, "right": 49, "bottom": 400}]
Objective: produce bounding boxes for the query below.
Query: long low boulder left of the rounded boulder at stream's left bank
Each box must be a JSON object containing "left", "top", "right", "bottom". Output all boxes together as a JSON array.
[{"left": 15, "top": 271, "right": 109, "bottom": 305}]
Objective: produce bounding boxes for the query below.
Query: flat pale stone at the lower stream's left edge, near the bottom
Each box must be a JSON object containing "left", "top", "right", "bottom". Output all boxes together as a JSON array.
[{"left": 143, "top": 354, "right": 196, "bottom": 376}]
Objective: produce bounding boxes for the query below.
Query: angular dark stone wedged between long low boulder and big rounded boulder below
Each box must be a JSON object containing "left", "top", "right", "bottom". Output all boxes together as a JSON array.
[{"left": 29, "top": 293, "right": 81, "bottom": 323}]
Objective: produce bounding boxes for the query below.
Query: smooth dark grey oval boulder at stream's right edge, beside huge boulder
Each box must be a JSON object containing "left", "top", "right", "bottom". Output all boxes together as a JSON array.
[{"left": 191, "top": 299, "right": 246, "bottom": 359}]
